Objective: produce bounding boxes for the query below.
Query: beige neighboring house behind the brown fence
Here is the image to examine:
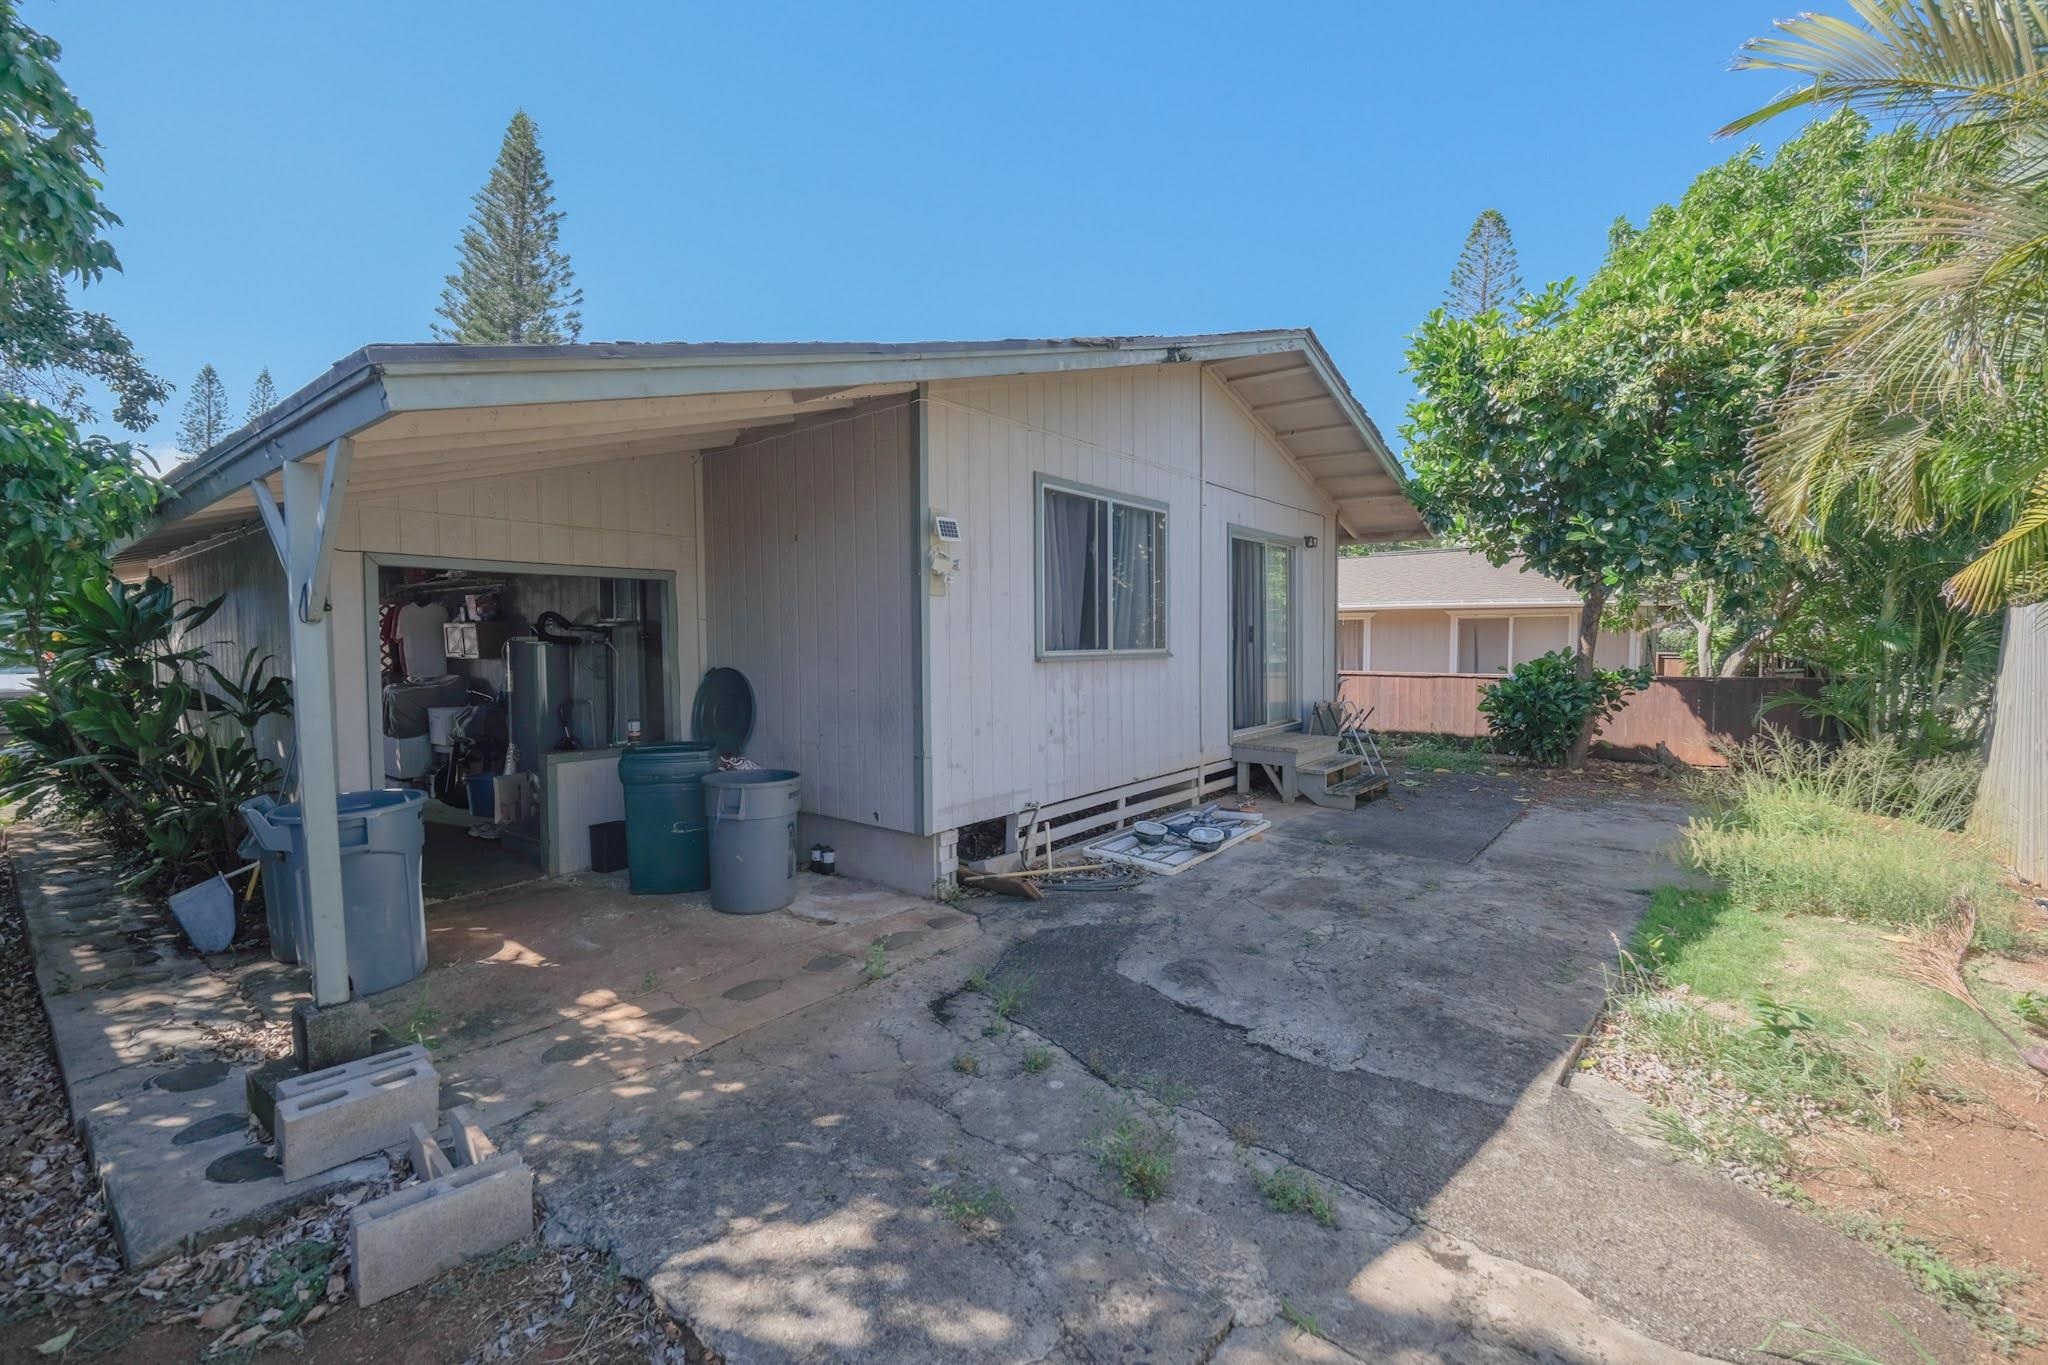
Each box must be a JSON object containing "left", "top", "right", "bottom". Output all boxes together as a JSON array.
[{"left": 1337, "top": 548, "right": 1645, "bottom": 673}]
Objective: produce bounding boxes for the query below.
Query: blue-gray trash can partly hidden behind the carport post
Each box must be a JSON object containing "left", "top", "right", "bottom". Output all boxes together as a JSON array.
[{"left": 242, "top": 788, "right": 426, "bottom": 995}]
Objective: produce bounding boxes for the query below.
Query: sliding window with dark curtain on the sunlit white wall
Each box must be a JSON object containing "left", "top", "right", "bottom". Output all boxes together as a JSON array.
[{"left": 1038, "top": 483, "right": 1165, "bottom": 655}]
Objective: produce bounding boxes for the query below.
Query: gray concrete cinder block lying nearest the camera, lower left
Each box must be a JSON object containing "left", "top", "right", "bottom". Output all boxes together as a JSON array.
[{"left": 348, "top": 1154, "right": 532, "bottom": 1308}]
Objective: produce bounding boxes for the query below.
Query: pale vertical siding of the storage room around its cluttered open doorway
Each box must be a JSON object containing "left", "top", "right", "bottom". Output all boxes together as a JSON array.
[{"left": 150, "top": 454, "right": 702, "bottom": 788}]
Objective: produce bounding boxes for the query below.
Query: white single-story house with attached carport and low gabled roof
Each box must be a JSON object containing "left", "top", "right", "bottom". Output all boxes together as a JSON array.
[{"left": 117, "top": 329, "right": 1423, "bottom": 1005}]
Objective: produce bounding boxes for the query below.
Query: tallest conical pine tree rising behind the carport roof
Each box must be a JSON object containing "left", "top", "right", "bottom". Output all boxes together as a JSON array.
[{"left": 434, "top": 108, "right": 584, "bottom": 344}]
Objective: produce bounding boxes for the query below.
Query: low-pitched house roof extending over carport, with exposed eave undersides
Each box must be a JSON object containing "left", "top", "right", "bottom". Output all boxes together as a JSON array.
[{"left": 119, "top": 327, "right": 1421, "bottom": 569}]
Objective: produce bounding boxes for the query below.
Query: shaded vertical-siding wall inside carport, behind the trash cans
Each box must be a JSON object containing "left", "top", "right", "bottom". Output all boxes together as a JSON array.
[{"left": 705, "top": 397, "right": 920, "bottom": 831}]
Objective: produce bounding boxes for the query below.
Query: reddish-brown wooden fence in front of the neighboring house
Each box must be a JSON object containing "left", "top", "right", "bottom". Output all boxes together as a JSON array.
[{"left": 1337, "top": 673, "right": 1827, "bottom": 767}]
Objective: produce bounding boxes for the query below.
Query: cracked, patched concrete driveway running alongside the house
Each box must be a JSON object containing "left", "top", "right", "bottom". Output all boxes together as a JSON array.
[{"left": 520, "top": 774, "right": 1970, "bottom": 1365}]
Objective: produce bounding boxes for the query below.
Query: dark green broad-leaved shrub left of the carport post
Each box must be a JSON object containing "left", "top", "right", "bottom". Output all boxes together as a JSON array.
[{"left": 0, "top": 579, "right": 291, "bottom": 886}]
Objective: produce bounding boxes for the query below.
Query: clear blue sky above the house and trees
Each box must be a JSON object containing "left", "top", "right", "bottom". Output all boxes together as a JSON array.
[{"left": 39, "top": 0, "right": 1794, "bottom": 464}]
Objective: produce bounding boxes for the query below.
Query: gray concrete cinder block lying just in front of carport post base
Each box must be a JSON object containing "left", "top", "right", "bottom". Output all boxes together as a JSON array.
[{"left": 272, "top": 1048, "right": 440, "bottom": 1181}]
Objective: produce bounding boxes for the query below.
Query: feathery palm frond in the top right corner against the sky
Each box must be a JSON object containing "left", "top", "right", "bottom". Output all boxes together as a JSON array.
[{"left": 1720, "top": 0, "right": 2048, "bottom": 137}]
